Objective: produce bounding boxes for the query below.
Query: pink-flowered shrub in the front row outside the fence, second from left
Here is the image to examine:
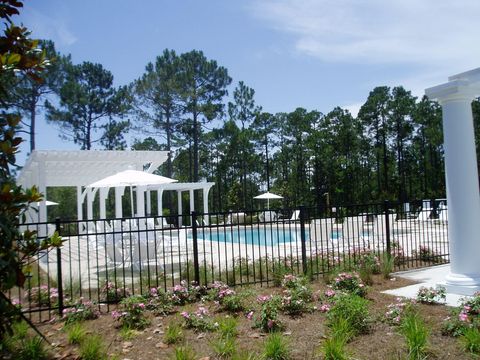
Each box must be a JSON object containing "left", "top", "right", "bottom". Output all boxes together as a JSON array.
[{"left": 112, "top": 295, "right": 150, "bottom": 330}]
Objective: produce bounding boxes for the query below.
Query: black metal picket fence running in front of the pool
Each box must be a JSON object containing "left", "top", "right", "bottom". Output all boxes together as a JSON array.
[{"left": 9, "top": 202, "right": 449, "bottom": 321}]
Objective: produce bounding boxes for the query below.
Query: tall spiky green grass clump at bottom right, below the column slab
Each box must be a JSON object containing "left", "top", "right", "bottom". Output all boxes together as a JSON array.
[{"left": 400, "top": 311, "right": 430, "bottom": 360}]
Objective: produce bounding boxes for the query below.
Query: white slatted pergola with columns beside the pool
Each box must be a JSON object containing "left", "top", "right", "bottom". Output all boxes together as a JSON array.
[{"left": 17, "top": 150, "right": 214, "bottom": 226}]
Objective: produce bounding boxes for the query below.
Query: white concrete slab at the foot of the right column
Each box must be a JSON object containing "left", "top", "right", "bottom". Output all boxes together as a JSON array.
[{"left": 383, "top": 264, "right": 465, "bottom": 306}]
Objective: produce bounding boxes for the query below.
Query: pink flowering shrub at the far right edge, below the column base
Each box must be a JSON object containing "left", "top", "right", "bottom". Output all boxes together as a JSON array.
[{"left": 442, "top": 292, "right": 480, "bottom": 336}]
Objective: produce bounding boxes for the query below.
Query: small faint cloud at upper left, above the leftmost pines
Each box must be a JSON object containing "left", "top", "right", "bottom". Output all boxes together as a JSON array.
[{"left": 23, "top": 8, "right": 77, "bottom": 49}]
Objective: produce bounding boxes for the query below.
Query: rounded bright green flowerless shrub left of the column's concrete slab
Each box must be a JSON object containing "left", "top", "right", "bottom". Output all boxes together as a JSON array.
[{"left": 327, "top": 294, "right": 370, "bottom": 335}]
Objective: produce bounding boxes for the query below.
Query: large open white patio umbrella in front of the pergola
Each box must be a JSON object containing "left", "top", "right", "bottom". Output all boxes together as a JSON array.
[{"left": 87, "top": 169, "right": 178, "bottom": 215}]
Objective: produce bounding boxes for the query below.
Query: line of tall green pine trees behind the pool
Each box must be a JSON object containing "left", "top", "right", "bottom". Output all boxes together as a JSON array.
[{"left": 8, "top": 41, "right": 480, "bottom": 211}]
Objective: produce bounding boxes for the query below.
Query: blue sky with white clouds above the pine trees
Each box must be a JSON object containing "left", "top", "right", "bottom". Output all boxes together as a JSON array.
[{"left": 14, "top": 0, "right": 480, "bottom": 163}]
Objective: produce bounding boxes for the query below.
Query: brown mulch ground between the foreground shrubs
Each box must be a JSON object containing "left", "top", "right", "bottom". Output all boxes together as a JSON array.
[{"left": 29, "top": 276, "right": 471, "bottom": 360}]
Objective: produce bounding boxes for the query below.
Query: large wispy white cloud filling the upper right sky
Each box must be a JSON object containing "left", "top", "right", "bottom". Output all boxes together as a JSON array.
[{"left": 251, "top": 0, "right": 480, "bottom": 73}]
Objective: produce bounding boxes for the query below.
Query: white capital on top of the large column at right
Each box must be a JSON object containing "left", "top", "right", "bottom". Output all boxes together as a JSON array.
[{"left": 425, "top": 78, "right": 480, "bottom": 104}]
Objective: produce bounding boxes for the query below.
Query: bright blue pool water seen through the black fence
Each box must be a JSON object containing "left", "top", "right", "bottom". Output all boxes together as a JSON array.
[{"left": 194, "top": 228, "right": 309, "bottom": 246}]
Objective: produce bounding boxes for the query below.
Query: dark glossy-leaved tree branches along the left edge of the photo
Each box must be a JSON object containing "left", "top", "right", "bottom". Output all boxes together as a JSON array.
[{"left": 0, "top": 2, "right": 56, "bottom": 339}]
